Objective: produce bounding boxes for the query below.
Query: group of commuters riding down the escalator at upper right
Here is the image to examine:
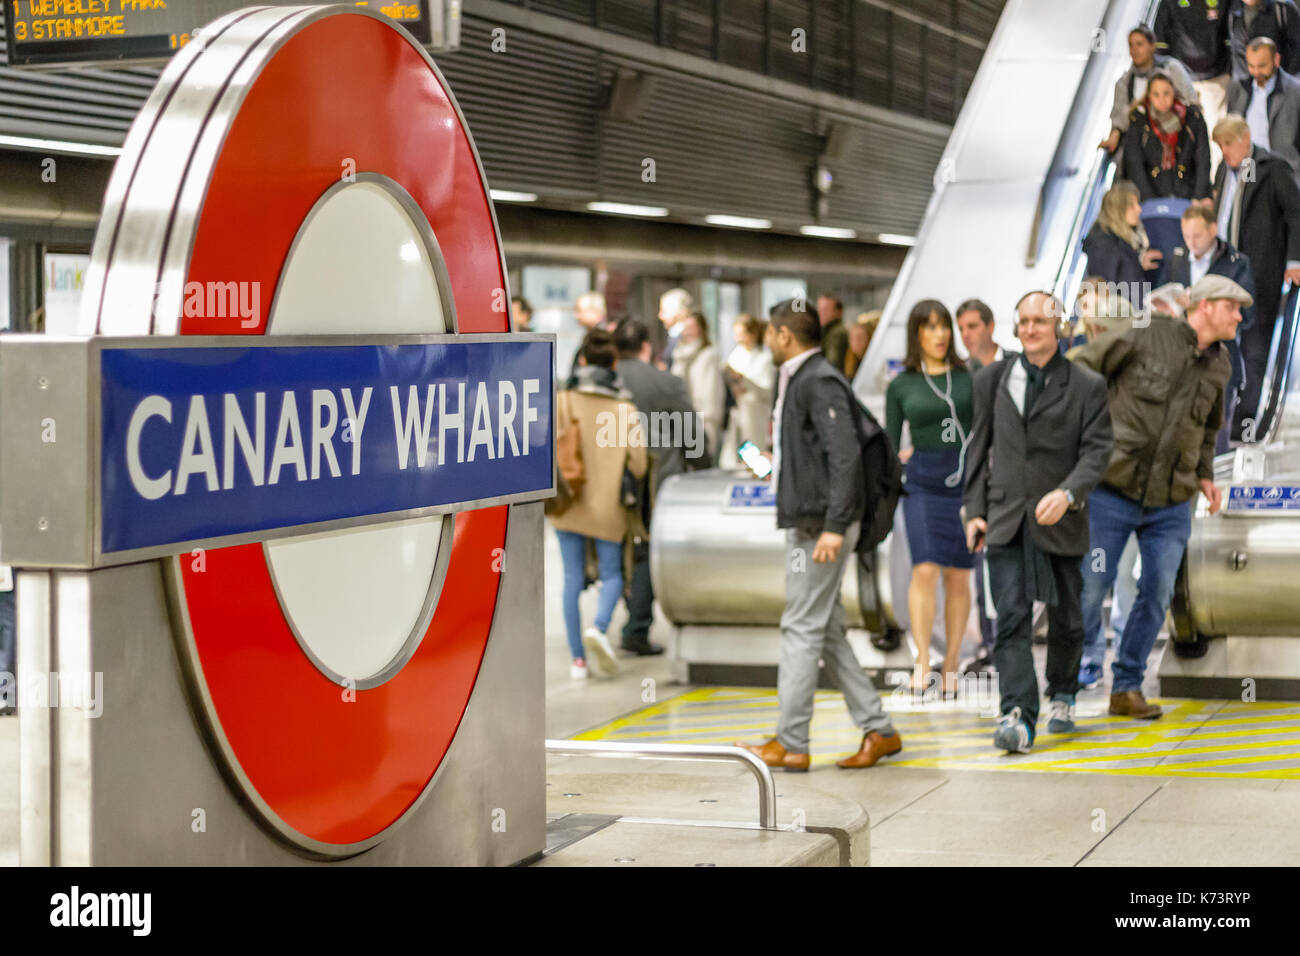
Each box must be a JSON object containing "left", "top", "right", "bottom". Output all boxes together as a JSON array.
[{"left": 1084, "top": 0, "right": 1300, "bottom": 451}]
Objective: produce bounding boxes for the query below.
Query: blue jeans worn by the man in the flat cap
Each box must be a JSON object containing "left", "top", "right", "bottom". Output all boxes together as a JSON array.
[{"left": 1083, "top": 488, "right": 1192, "bottom": 693}]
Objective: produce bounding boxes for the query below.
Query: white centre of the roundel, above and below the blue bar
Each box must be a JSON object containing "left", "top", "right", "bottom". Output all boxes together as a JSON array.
[{"left": 265, "top": 177, "right": 451, "bottom": 682}]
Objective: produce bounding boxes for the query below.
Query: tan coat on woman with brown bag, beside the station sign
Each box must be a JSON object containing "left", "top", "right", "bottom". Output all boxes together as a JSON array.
[{"left": 551, "top": 392, "right": 646, "bottom": 541}]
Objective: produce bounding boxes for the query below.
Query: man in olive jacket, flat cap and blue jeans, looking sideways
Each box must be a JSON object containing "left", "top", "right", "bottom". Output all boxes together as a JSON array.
[{"left": 1074, "top": 276, "right": 1252, "bottom": 718}]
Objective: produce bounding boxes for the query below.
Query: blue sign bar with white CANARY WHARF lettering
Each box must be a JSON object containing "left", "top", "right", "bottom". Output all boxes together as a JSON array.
[{"left": 99, "top": 337, "right": 554, "bottom": 554}]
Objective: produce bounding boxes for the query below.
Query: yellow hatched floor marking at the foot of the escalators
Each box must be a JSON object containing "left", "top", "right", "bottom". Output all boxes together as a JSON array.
[{"left": 576, "top": 687, "right": 1300, "bottom": 779}]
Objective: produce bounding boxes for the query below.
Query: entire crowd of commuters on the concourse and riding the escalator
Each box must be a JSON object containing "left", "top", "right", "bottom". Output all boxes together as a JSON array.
[{"left": 540, "top": 0, "right": 1300, "bottom": 770}]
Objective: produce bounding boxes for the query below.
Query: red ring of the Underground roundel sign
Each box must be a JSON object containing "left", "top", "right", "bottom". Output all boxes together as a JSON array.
[{"left": 114, "top": 13, "right": 510, "bottom": 856}]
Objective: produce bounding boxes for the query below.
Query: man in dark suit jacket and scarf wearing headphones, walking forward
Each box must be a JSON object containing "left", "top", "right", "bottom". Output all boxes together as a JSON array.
[{"left": 965, "top": 293, "right": 1112, "bottom": 753}]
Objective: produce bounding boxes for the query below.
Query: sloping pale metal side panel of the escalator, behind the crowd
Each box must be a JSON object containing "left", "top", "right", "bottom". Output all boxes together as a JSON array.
[{"left": 854, "top": 0, "right": 1158, "bottom": 416}]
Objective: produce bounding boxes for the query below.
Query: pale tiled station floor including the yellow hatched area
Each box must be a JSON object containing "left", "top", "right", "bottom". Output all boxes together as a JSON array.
[{"left": 546, "top": 535, "right": 1300, "bottom": 866}]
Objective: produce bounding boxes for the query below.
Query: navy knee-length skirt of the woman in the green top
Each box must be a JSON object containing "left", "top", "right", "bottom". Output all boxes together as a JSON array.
[{"left": 902, "top": 449, "right": 975, "bottom": 568}]
